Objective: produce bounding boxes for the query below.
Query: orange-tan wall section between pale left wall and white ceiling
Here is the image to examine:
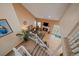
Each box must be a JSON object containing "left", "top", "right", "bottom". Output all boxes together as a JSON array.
[{"left": 13, "top": 4, "right": 35, "bottom": 25}]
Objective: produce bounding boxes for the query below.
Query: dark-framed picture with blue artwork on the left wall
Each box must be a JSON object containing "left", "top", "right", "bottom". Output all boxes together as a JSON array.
[{"left": 0, "top": 19, "right": 13, "bottom": 37}]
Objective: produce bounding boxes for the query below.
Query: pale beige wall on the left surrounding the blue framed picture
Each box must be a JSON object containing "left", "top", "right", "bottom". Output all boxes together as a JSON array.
[{"left": 0, "top": 4, "right": 21, "bottom": 55}]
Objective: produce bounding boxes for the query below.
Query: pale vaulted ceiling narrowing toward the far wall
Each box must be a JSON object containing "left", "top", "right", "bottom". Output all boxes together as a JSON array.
[{"left": 22, "top": 3, "right": 69, "bottom": 20}]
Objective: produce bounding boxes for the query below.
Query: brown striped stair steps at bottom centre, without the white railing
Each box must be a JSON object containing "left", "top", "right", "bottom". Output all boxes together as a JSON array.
[{"left": 31, "top": 44, "right": 49, "bottom": 56}]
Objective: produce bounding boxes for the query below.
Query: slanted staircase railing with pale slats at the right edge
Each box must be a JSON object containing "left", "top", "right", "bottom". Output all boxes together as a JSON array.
[{"left": 65, "top": 22, "right": 79, "bottom": 56}]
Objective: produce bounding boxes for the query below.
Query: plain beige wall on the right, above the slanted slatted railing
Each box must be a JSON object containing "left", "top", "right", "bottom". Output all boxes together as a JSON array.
[{"left": 60, "top": 4, "right": 79, "bottom": 37}]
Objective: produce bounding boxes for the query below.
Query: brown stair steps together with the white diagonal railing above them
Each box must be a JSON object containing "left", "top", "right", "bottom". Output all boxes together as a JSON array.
[{"left": 29, "top": 33, "right": 49, "bottom": 56}]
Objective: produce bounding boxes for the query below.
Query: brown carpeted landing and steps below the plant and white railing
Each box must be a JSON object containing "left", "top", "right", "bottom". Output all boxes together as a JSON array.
[{"left": 7, "top": 40, "right": 49, "bottom": 56}]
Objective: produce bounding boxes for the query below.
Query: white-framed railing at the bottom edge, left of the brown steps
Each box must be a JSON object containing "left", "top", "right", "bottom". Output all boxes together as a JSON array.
[{"left": 13, "top": 46, "right": 31, "bottom": 56}]
